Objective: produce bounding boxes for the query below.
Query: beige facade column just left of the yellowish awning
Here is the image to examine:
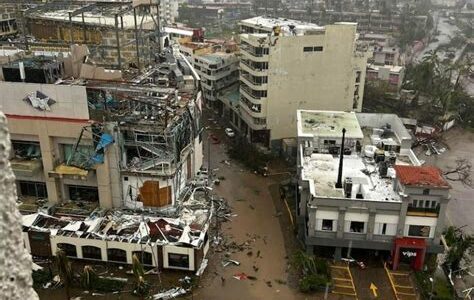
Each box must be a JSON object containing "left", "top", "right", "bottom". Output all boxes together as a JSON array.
[{"left": 36, "top": 122, "right": 63, "bottom": 203}]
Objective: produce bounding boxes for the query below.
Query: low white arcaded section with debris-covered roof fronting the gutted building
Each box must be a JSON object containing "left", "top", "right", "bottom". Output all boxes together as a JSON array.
[{"left": 23, "top": 188, "right": 212, "bottom": 271}]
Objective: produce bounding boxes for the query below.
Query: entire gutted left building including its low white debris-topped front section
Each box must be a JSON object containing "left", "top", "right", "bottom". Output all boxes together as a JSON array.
[{"left": 0, "top": 37, "right": 207, "bottom": 271}]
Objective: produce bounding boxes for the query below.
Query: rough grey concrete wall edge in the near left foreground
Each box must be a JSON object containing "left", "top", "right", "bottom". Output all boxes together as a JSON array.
[{"left": 0, "top": 112, "right": 38, "bottom": 300}]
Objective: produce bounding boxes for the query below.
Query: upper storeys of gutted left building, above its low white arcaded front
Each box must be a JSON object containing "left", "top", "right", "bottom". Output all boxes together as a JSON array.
[{"left": 0, "top": 45, "right": 202, "bottom": 216}]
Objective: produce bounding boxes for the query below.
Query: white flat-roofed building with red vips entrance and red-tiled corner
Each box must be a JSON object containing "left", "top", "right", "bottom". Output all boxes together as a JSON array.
[{"left": 297, "top": 110, "right": 450, "bottom": 270}]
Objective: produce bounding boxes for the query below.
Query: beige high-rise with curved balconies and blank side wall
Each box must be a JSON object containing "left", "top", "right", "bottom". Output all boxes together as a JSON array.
[{"left": 235, "top": 17, "right": 370, "bottom": 149}]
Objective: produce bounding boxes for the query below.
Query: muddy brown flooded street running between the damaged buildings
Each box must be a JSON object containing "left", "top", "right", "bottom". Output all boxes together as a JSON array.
[{"left": 194, "top": 122, "right": 308, "bottom": 299}]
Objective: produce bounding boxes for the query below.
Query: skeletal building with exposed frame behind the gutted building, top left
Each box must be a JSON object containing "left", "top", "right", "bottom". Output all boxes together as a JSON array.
[{"left": 10, "top": 0, "right": 163, "bottom": 69}]
